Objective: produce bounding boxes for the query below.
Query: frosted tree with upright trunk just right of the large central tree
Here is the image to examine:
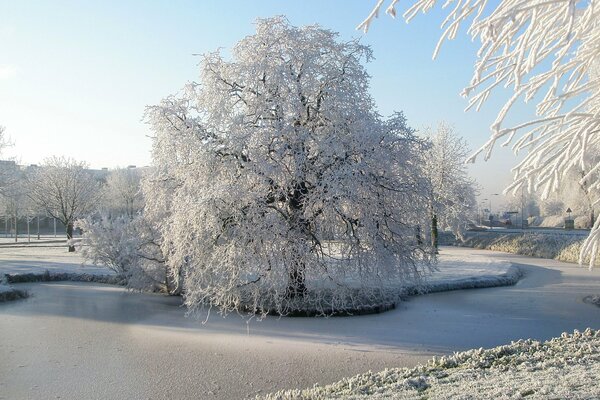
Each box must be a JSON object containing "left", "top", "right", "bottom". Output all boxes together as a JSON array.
[{"left": 423, "top": 123, "right": 477, "bottom": 248}]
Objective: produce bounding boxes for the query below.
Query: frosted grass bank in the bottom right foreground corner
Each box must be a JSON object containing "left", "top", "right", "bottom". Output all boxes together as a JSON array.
[{"left": 265, "top": 328, "right": 600, "bottom": 400}]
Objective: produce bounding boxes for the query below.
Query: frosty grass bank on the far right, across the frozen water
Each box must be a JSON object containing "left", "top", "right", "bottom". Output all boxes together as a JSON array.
[{"left": 460, "top": 232, "right": 600, "bottom": 265}]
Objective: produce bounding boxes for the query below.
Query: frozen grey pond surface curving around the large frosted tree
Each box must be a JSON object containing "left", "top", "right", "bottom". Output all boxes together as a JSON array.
[{"left": 0, "top": 249, "right": 600, "bottom": 399}]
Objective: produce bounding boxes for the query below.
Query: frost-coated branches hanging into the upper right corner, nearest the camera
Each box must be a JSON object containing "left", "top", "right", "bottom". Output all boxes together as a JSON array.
[{"left": 358, "top": 0, "right": 600, "bottom": 267}]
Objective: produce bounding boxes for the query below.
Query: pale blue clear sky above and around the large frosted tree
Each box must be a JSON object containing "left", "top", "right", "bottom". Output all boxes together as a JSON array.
[{"left": 0, "top": 0, "right": 536, "bottom": 203}]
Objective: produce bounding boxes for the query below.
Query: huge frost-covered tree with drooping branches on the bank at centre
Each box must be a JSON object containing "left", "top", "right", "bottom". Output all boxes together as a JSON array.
[{"left": 145, "top": 17, "right": 429, "bottom": 313}]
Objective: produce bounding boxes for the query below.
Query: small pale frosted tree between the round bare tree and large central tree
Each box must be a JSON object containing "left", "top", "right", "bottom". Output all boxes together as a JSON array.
[{"left": 103, "top": 168, "right": 143, "bottom": 219}]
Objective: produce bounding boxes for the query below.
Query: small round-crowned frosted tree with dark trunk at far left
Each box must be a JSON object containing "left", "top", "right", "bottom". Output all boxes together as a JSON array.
[{"left": 27, "top": 157, "right": 100, "bottom": 252}]
